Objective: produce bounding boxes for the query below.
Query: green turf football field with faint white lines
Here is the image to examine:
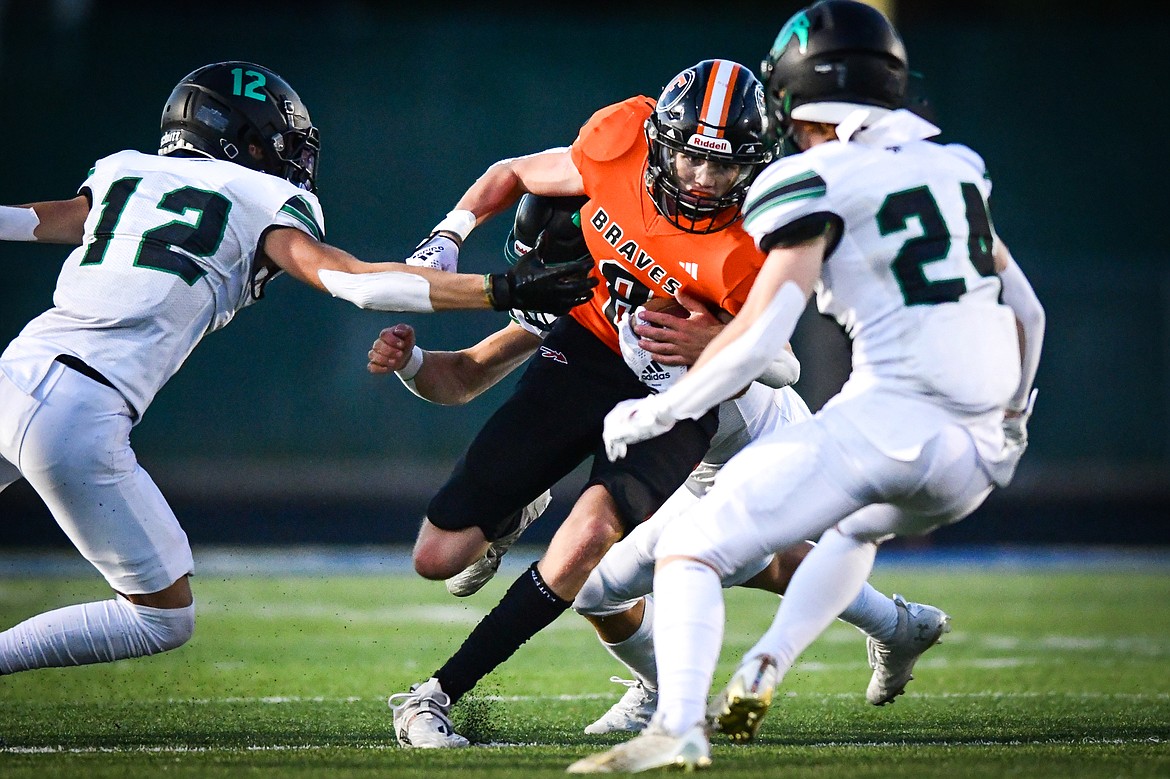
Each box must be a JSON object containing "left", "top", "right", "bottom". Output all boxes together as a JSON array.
[{"left": 0, "top": 549, "right": 1170, "bottom": 779}]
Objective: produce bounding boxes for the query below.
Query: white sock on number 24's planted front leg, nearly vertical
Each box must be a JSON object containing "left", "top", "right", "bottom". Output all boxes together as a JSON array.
[{"left": 654, "top": 560, "right": 723, "bottom": 735}]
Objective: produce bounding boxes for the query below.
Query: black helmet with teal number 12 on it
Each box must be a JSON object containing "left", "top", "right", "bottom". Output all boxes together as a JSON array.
[{"left": 158, "top": 62, "right": 321, "bottom": 192}]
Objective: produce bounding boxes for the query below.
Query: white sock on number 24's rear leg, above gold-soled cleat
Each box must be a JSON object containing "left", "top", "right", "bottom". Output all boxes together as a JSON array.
[{"left": 748, "top": 529, "right": 878, "bottom": 677}]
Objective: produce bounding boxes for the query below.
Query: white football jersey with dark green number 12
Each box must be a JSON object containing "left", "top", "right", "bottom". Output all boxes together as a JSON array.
[{"left": 0, "top": 151, "right": 324, "bottom": 416}]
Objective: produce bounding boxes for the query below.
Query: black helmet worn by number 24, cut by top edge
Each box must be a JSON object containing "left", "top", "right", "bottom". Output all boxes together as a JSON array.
[{"left": 759, "top": 0, "right": 909, "bottom": 143}]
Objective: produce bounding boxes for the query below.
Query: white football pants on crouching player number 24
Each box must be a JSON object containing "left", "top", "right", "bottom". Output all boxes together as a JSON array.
[{"left": 655, "top": 402, "right": 992, "bottom": 577}]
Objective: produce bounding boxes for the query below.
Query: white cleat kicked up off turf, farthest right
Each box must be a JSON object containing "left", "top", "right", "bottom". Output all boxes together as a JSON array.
[{"left": 866, "top": 595, "right": 950, "bottom": 706}]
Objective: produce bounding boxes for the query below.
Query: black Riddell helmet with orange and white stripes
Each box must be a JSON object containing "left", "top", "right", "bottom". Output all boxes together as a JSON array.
[{"left": 646, "top": 60, "right": 772, "bottom": 233}]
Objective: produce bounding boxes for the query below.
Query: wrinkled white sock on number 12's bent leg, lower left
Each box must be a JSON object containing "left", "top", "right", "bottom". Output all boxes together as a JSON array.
[{"left": 0, "top": 595, "right": 195, "bottom": 674}]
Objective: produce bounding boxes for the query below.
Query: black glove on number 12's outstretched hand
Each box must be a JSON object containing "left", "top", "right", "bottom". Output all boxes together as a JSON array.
[{"left": 487, "top": 241, "right": 597, "bottom": 316}]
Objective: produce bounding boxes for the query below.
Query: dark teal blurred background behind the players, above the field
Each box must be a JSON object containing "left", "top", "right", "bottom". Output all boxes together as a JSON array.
[{"left": 0, "top": 0, "right": 1170, "bottom": 546}]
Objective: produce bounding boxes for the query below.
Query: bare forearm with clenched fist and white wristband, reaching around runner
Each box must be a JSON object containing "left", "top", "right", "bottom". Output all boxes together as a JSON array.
[{"left": 367, "top": 323, "right": 541, "bottom": 406}]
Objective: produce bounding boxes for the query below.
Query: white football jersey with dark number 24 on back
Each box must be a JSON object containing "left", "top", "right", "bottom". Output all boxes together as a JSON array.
[{"left": 744, "top": 111, "right": 1019, "bottom": 460}]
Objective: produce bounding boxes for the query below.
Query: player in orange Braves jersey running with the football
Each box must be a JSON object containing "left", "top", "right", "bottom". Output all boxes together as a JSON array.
[{"left": 391, "top": 60, "right": 791, "bottom": 747}]
